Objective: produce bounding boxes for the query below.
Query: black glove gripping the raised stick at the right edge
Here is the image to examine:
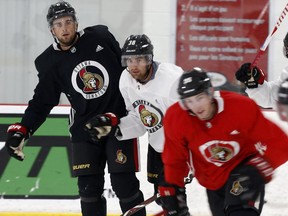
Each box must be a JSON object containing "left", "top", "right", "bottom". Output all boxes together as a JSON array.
[{"left": 235, "top": 63, "right": 265, "bottom": 88}]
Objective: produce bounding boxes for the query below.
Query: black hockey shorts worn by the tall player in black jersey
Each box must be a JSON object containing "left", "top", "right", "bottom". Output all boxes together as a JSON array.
[{"left": 72, "top": 137, "right": 139, "bottom": 176}]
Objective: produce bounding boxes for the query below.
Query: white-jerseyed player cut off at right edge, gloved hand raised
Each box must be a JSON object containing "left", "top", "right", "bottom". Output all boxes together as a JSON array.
[{"left": 235, "top": 33, "right": 288, "bottom": 109}]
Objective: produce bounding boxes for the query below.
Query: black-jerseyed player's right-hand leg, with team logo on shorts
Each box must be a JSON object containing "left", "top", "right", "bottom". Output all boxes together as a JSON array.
[{"left": 106, "top": 137, "right": 146, "bottom": 216}]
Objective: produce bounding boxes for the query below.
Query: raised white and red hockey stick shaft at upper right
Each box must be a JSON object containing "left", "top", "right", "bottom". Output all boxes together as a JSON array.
[{"left": 250, "top": 3, "right": 288, "bottom": 68}]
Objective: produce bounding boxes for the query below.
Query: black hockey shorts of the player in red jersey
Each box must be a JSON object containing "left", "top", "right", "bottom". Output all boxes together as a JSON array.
[{"left": 207, "top": 165, "right": 265, "bottom": 216}]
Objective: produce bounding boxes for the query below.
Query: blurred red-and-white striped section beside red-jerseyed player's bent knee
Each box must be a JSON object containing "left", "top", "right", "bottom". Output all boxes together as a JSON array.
[{"left": 246, "top": 155, "right": 274, "bottom": 183}]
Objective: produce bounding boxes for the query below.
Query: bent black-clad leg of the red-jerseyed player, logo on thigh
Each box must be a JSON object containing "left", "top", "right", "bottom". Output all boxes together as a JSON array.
[{"left": 225, "top": 165, "right": 265, "bottom": 216}]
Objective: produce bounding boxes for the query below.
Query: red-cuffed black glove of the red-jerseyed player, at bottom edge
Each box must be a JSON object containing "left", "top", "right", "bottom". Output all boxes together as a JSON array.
[{"left": 158, "top": 186, "right": 190, "bottom": 216}]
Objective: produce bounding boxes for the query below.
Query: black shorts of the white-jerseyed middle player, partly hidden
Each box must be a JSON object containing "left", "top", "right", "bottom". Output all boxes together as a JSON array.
[{"left": 147, "top": 144, "right": 164, "bottom": 185}]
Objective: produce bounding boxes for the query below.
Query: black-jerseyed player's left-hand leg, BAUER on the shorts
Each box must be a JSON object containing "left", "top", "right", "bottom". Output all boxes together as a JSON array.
[{"left": 73, "top": 142, "right": 106, "bottom": 216}]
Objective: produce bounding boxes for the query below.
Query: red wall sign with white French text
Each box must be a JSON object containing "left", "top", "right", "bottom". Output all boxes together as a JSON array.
[{"left": 176, "top": 0, "right": 269, "bottom": 83}]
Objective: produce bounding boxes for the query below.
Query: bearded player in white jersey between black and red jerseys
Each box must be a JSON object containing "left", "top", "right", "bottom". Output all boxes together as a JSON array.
[{"left": 88, "top": 34, "right": 190, "bottom": 216}]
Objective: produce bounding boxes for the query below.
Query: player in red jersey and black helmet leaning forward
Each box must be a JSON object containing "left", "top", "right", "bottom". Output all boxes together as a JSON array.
[{"left": 160, "top": 68, "right": 288, "bottom": 216}]
